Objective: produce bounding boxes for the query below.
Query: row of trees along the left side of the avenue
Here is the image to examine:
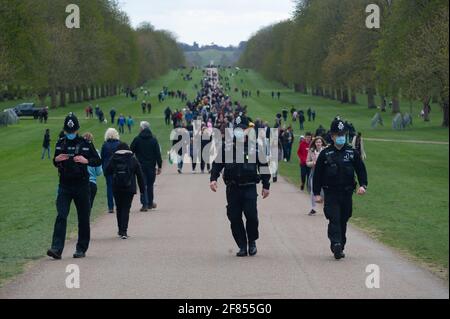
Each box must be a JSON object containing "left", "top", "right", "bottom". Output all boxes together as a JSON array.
[{"left": 0, "top": 0, "right": 185, "bottom": 107}]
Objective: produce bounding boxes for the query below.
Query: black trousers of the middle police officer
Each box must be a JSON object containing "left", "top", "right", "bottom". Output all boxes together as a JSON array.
[{"left": 226, "top": 185, "right": 259, "bottom": 248}]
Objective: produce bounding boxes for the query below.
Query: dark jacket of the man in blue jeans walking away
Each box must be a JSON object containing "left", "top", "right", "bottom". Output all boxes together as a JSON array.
[{"left": 131, "top": 129, "right": 162, "bottom": 169}]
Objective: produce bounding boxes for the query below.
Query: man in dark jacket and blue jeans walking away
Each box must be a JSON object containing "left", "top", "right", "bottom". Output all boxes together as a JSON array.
[{"left": 130, "top": 121, "right": 162, "bottom": 212}]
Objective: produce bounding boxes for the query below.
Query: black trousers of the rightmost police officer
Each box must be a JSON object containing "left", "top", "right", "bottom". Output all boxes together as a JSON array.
[{"left": 324, "top": 190, "right": 353, "bottom": 248}]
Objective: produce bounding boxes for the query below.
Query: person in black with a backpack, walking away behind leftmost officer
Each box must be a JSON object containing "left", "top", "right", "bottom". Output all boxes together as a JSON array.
[{"left": 105, "top": 143, "right": 145, "bottom": 239}]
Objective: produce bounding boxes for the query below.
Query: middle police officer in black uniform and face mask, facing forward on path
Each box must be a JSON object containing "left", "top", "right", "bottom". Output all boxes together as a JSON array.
[{"left": 210, "top": 116, "right": 270, "bottom": 257}]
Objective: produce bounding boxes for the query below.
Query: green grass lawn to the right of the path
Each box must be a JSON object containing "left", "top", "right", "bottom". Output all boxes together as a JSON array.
[{"left": 222, "top": 71, "right": 449, "bottom": 277}]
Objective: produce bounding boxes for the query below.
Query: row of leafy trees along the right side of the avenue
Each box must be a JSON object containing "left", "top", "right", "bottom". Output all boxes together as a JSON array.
[{"left": 239, "top": 0, "right": 449, "bottom": 127}]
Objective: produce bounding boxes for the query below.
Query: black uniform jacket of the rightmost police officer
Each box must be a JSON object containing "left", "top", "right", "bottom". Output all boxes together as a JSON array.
[{"left": 313, "top": 145, "right": 368, "bottom": 196}]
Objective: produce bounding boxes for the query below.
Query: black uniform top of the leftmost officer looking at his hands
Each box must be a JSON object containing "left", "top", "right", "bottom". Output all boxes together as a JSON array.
[{"left": 53, "top": 136, "right": 102, "bottom": 186}]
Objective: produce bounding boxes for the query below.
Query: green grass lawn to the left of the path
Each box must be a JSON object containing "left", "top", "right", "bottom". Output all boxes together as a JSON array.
[{"left": 0, "top": 71, "right": 201, "bottom": 284}]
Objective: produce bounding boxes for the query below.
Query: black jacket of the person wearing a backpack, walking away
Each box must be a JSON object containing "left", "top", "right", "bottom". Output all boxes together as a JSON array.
[{"left": 104, "top": 150, "right": 145, "bottom": 194}]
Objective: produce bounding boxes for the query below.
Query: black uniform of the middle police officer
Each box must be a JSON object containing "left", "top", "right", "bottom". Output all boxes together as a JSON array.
[{"left": 211, "top": 120, "right": 271, "bottom": 256}]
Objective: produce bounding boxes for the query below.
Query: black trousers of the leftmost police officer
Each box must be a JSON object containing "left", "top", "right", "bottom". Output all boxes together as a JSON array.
[{"left": 52, "top": 183, "right": 91, "bottom": 254}]
